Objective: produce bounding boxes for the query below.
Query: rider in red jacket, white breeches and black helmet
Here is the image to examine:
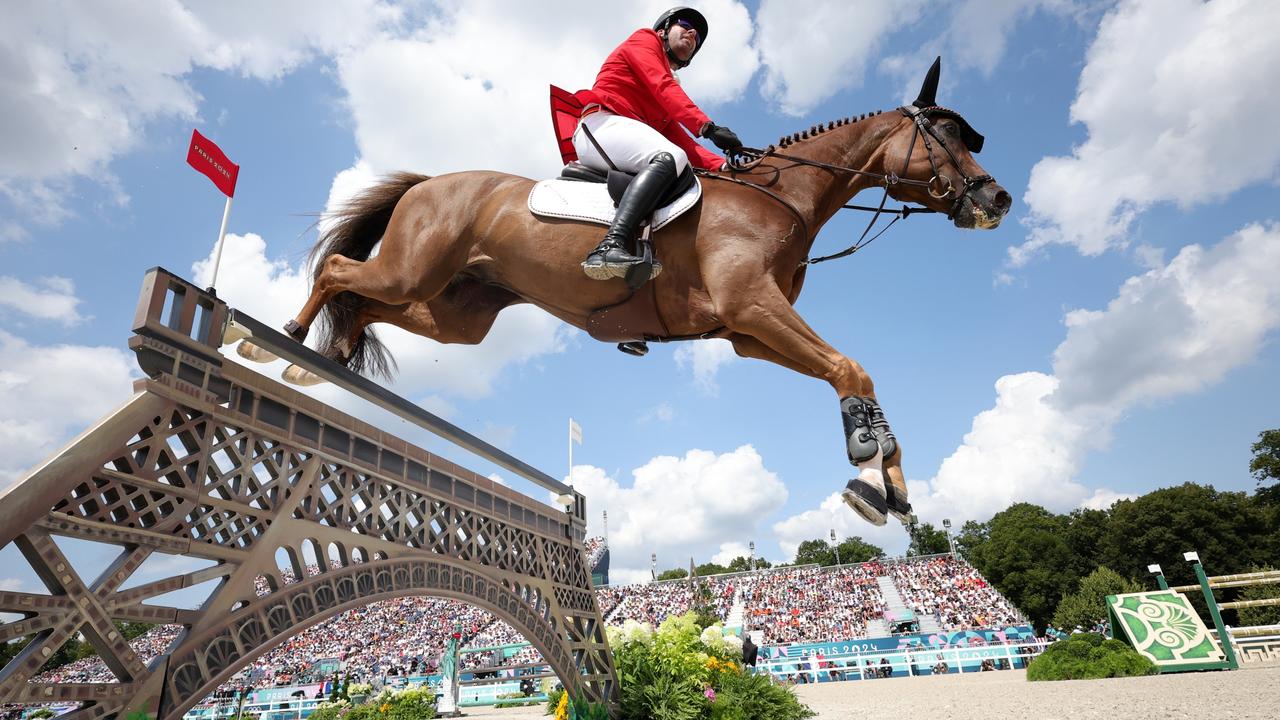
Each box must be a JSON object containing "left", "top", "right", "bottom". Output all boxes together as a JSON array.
[{"left": 573, "top": 8, "right": 742, "bottom": 281}]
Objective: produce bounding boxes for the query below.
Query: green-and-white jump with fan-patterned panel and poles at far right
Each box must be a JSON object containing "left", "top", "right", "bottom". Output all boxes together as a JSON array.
[{"left": 1107, "top": 552, "right": 1280, "bottom": 673}]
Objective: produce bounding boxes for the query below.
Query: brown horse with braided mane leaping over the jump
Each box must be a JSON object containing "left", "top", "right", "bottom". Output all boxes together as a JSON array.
[{"left": 252, "top": 58, "right": 1011, "bottom": 525}]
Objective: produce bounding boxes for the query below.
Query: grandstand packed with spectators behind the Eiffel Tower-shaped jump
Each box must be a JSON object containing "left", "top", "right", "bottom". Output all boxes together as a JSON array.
[{"left": 22, "top": 538, "right": 1025, "bottom": 691}]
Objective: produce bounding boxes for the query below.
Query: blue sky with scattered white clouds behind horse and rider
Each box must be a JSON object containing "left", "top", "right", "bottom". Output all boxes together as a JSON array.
[{"left": 0, "top": 0, "right": 1280, "bottom": 587}]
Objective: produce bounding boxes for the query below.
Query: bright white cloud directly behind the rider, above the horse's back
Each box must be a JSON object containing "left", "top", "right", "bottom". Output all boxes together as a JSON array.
[{"left": 338, "top": 0, "right": 756, "bottom": 177}]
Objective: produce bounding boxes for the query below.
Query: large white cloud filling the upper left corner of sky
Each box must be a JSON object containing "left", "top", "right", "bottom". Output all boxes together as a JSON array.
[{"left": 0, "top": 0, "right": 401, "bottom": 224}]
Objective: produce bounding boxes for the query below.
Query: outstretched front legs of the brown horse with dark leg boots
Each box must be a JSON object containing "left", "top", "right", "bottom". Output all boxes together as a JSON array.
[{"left": 712, "top": 282, "right": 910, "bottom": 525}]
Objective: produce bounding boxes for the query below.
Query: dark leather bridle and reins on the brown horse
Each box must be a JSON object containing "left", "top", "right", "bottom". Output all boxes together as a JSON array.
[{"left": 699, "top": 105, "right": 995, "bottom": 266}]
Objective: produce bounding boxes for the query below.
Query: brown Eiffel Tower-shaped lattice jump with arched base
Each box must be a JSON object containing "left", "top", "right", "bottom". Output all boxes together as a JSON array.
[{"left": 0, "top": 269, "right": 617, "bottom": 719}]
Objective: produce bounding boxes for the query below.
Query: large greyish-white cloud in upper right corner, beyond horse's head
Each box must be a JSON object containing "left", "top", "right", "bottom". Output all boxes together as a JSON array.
[{"left": 1010, "top": 0, "right": 1280, "bottom": 265}]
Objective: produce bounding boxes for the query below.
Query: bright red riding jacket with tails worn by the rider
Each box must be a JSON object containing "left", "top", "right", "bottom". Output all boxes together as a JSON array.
[{"left": 552, "top": 28, "right": 724, "bottom": 170}]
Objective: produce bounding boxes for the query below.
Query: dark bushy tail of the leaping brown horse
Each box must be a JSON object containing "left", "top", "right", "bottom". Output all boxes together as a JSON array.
[{"left": 308, "top": 173, "right": 430, "bottom": 379}]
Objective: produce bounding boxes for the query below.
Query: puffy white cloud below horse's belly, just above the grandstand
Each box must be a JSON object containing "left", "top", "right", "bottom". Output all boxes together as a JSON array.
[{"left": 573, "top": 445, "right": 787, "bottom": 583}]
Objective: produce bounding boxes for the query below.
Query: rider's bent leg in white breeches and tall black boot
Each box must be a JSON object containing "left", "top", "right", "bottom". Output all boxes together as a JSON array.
[{"left": 573, "top": 110, "right": 689, "bottom": 279}]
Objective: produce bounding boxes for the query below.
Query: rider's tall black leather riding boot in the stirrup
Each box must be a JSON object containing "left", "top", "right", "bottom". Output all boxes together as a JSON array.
[{"left": 582, "top": 152, "right": 676, "bottom": 281}]
